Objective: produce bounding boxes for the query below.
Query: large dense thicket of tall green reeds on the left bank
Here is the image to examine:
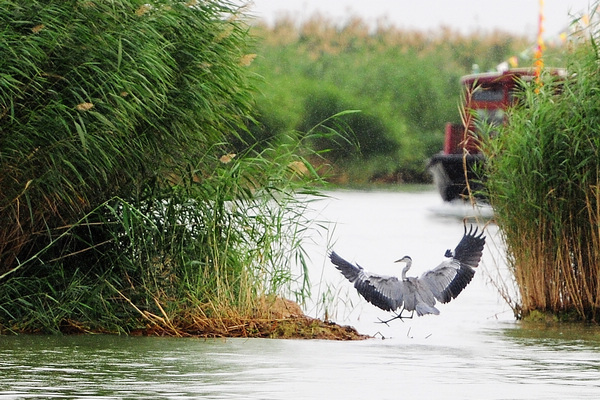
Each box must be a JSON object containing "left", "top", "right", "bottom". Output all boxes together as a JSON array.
[{"left": 0, "top": 0, "right": 324, "bottom": 331}]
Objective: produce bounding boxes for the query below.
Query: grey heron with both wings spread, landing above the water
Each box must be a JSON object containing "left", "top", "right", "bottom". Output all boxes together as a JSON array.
[{"left": 329, "top": 225, "right": 485, "bottom": 324}]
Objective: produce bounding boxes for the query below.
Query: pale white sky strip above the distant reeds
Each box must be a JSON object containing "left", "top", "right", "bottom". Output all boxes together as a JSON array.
[{"left": 245, "top": 0, "right": 596, "bottom": 38}]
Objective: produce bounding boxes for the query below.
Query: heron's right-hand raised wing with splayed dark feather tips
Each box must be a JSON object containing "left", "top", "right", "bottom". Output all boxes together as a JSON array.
[{"left": 419, "top": 225, "right": 485, "bottom": 303}]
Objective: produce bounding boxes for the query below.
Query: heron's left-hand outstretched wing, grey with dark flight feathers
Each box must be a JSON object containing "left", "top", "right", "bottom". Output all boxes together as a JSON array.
[{"left": 329, "top": 252, "right": 404, "bottom": 311}]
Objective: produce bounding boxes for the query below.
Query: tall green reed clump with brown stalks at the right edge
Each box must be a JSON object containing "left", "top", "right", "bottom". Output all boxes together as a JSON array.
[{"left": 487, "top": 8, "right": 600, "bottom": 322}]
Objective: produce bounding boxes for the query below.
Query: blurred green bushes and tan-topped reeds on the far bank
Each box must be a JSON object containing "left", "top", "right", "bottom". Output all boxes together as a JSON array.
[{"left": 251, "top": 16, "right": 530, "bottom": 182}]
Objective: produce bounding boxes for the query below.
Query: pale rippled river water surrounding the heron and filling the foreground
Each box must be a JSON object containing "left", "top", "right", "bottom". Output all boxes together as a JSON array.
[{"left": 0, "top": 188, "right": 600, "bottom": 399}]
